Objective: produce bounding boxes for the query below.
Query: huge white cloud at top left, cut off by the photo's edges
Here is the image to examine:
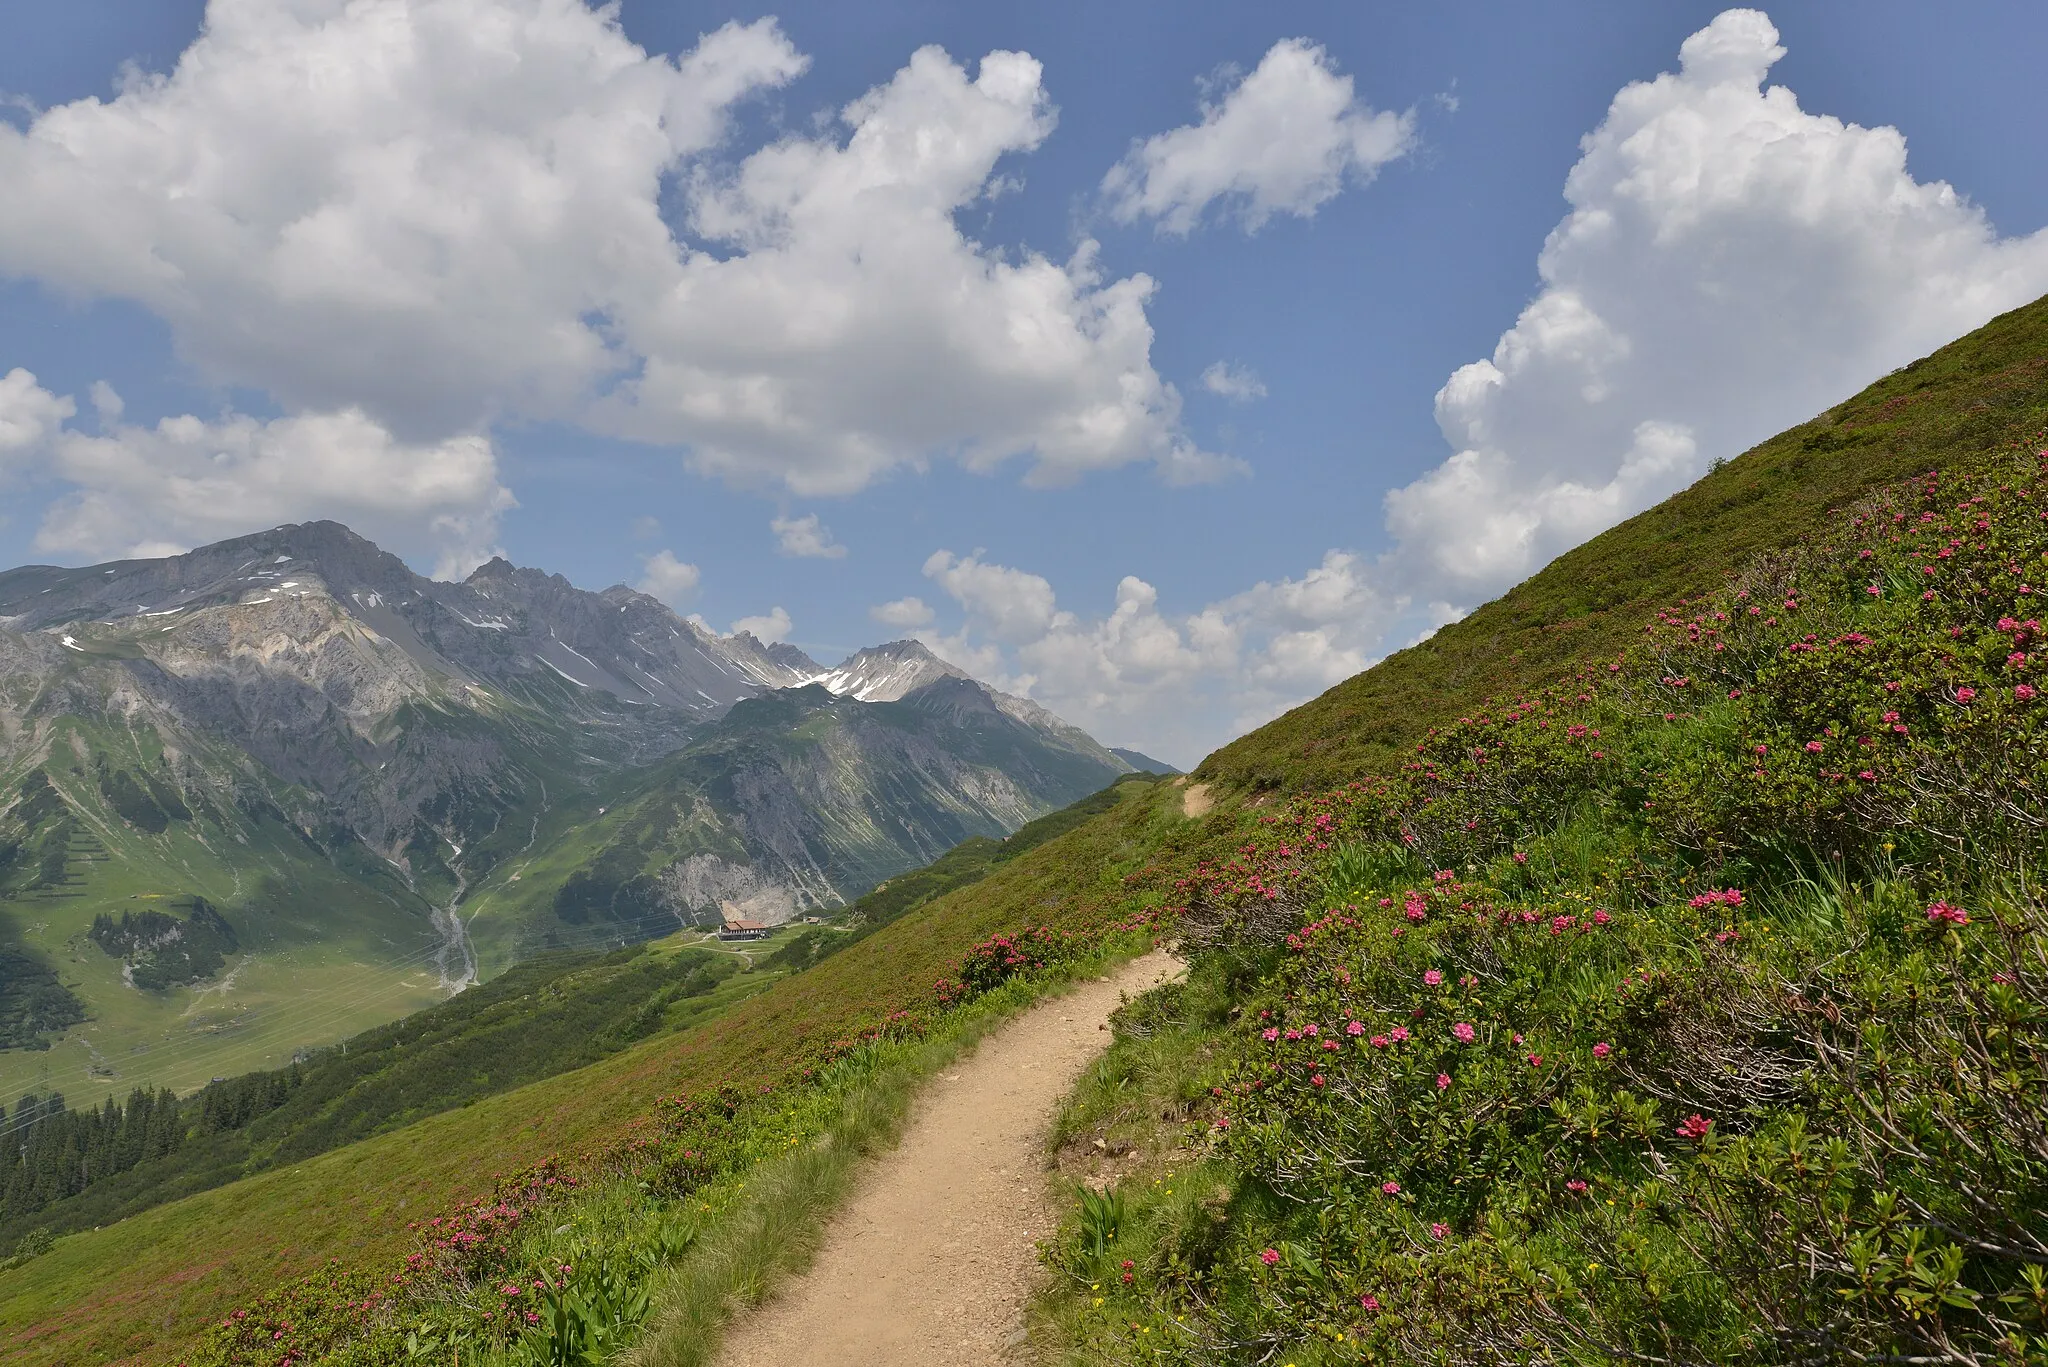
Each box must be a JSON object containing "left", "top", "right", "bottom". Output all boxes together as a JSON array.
[{"left": 0, "top": 0, "right": 805, "bottom": 434}]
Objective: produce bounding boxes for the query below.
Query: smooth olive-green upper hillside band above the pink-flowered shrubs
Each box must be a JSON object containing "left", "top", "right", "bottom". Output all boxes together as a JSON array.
[{"left": 1196, "top": 299, "right": 2048, "bottom": 791}]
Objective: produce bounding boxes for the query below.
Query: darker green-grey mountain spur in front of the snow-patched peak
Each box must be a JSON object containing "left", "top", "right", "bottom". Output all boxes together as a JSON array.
[{"left": 467, "top": 674, "right": 1128, "bottom": 963}]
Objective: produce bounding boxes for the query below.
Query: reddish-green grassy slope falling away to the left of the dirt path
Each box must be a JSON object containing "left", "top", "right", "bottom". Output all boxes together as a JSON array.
[{"left": 0, "top": 783, "right": 1194, "bottom": 1363}]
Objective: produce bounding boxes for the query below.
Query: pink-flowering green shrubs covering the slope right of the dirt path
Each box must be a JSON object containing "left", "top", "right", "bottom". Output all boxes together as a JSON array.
[{"left": 1056, "top": 451, "right": 2048, "bottom": 1363}]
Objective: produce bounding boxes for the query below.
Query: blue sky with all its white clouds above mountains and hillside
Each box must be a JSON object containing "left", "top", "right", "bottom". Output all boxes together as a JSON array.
[{"left": 0, "top": 0, "right": 2048, "bottom": 762}]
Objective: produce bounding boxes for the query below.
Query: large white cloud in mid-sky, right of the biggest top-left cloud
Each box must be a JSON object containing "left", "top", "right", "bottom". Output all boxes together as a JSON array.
[{"left": 596, "top": 47, "right": 1231, "bottom": 494}]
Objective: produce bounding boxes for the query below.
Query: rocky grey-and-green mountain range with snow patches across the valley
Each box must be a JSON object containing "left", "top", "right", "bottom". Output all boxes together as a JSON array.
[{"left": 0, "top": 523, "right": 1138, "bottom": 1094}]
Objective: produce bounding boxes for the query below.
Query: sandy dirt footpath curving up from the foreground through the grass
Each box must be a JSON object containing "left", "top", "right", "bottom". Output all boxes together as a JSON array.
[{"left": 717, "top": 953, "right": 1180, "bottom": 1367}]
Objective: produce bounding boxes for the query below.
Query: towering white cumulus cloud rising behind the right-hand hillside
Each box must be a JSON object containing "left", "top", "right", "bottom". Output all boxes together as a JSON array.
[{"left": 1386, "top": 10, "right": 2048, "bottom": 603}]
